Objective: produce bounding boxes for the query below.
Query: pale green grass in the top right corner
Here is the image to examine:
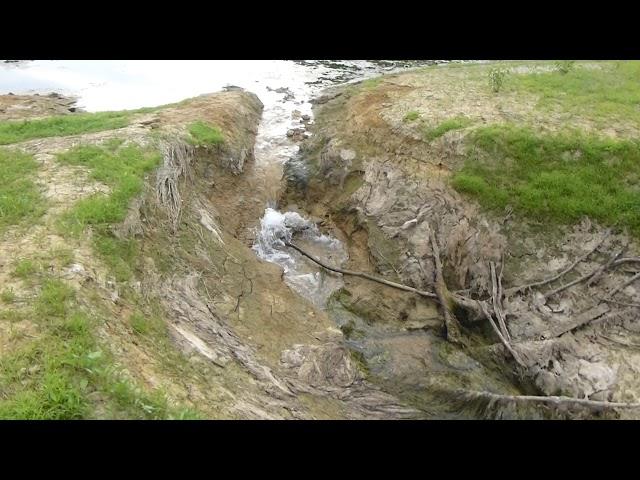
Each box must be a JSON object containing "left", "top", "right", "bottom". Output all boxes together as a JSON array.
[{"left": 509, "top": 61, "right": 640, "bottom": 124}]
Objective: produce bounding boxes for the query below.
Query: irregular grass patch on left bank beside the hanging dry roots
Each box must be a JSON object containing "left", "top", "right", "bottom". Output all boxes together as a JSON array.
[{"left": 58, "top": 140, "right": 160, "bottom": 281}]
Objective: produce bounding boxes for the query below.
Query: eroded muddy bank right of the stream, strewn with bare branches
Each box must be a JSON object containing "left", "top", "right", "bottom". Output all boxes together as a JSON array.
[{"left": 281, "top": 65, "right": 640, "bottom": 418}]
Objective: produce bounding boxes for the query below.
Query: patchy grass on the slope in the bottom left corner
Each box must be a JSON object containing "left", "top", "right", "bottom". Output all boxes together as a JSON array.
[{"left": 0, "top": 278, "right": 198, "bottom": 420}]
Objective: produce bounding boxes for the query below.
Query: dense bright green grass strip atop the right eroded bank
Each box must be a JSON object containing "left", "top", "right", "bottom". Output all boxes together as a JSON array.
[{"left": 452, "top": 125, "right": 640, "bottom": 235}]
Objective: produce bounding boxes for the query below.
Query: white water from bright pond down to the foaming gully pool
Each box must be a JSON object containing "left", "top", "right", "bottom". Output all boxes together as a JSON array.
[{"left": 0, "top": 60, "right": 436, "bottom": 306}]
